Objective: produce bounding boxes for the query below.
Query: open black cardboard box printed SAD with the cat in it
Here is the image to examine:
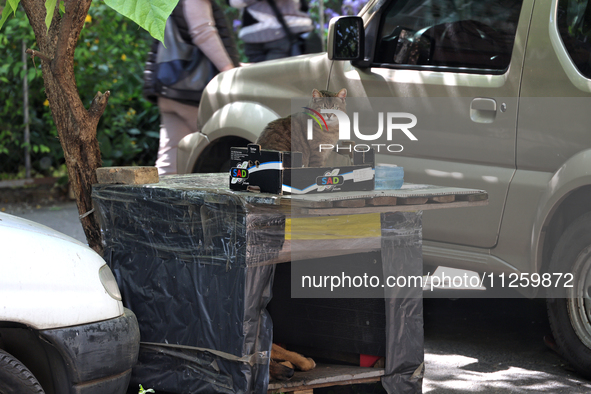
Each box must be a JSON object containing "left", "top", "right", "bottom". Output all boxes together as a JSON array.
[{"left": 230, "top": 144, "right": 375, "bottom": 194}]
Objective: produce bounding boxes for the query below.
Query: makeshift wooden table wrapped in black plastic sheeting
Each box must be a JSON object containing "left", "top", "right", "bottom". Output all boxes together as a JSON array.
[{"left": 92, "top": 174, "right": 487, "bottom": 393}]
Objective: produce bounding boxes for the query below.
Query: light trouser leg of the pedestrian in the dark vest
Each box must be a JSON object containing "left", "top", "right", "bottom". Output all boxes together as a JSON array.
[{"left": 156, "top": 97, "right": 198, "bottom": 175}]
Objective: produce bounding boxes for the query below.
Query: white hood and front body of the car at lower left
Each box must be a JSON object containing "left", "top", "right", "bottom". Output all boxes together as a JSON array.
[{"left": 0, "top": 213, "right": 123, "bottom": 329}]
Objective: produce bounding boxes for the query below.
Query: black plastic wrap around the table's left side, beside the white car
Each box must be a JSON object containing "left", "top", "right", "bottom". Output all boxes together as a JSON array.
[{"left": 93, "top": 176, "right": 285, "bottom": 393}]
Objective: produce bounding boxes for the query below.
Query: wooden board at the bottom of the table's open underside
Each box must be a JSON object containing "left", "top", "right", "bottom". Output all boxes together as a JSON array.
[{"left": 268, "top": 364, "right": 384, "bottom": 393}]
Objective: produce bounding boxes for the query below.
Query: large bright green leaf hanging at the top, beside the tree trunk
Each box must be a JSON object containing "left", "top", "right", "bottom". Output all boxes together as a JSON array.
[{"left": 104, "top": 0, "right": 179, "bottom": 41}]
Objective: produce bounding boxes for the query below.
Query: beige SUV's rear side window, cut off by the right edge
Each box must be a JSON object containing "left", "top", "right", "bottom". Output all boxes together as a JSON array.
[{"left": 556, "top": 0, "right": 591, "bottom": 78}]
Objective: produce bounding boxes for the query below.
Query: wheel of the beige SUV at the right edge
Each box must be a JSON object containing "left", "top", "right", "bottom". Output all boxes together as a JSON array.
[{"left": 547, "top": 213, "right": 591, "bottom": 379}]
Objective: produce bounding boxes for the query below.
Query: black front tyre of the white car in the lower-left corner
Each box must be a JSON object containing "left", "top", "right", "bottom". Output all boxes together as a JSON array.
[{"left": 0, "top": 349, "right": 45, "bottom": 394}]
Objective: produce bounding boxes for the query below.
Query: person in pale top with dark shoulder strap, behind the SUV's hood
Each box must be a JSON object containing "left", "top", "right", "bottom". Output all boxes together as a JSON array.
[{"left": 229, "top": 0, "right": 314, "bottom": 63}]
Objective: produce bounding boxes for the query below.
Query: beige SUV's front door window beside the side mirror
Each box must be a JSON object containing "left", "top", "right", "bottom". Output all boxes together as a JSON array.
[{"left": 373, "top": 0, "right": 522, "bottom": 73}]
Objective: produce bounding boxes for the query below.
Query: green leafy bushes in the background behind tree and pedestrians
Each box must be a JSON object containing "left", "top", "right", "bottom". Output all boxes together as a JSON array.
[{"left": 0, "top": 0, "right": 365, "bottom": 180}]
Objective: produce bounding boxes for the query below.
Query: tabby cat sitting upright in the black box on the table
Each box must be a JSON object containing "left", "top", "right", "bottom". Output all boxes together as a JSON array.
[{"left": 256, "top": 89, "right": 347, "bottom": 167}]
